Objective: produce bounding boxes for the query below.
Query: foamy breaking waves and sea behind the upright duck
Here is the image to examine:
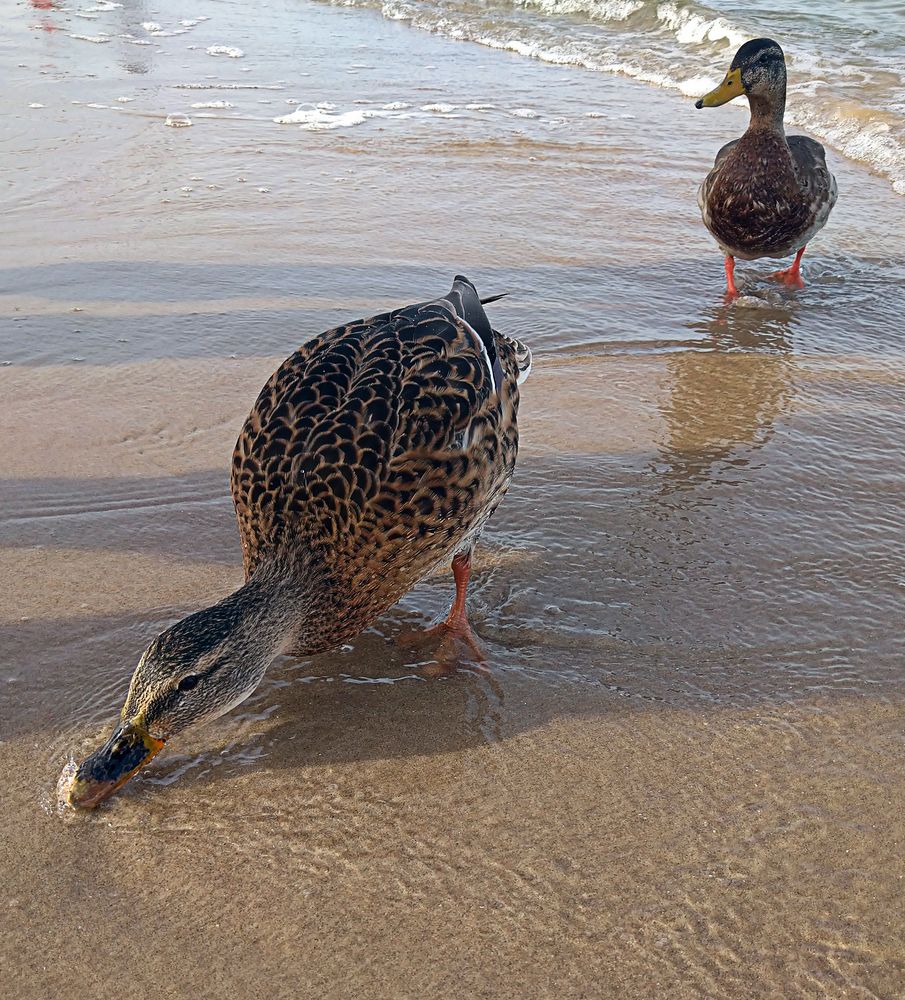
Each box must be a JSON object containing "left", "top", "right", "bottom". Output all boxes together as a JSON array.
[{"left": 312, "top": 0, "right": 905, "bottom": 194}]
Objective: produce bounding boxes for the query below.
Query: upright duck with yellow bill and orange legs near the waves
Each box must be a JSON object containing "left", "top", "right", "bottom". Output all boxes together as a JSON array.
[{"left": 695, "top": 38, "right": 836, "bottom": 298}]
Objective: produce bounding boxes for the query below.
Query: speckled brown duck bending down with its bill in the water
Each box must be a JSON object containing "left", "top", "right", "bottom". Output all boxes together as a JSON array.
[{"left": 67, "top": 277, "right": 531, "bottom": 807}]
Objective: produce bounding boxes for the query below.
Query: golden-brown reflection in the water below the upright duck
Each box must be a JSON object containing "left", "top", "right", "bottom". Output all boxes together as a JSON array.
[{"left": 657, "top": 306, "right": 794, "bottom": 492}]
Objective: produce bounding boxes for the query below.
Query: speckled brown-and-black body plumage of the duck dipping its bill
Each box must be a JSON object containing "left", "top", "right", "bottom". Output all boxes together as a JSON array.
[{"left": 231, "top": 278, "right": 530, "bottom": 653}]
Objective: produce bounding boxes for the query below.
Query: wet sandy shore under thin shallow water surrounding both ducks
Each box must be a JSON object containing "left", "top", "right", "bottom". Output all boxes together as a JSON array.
[{"left": 0, "top": 0, "right": 905, "bottom": 998}]
